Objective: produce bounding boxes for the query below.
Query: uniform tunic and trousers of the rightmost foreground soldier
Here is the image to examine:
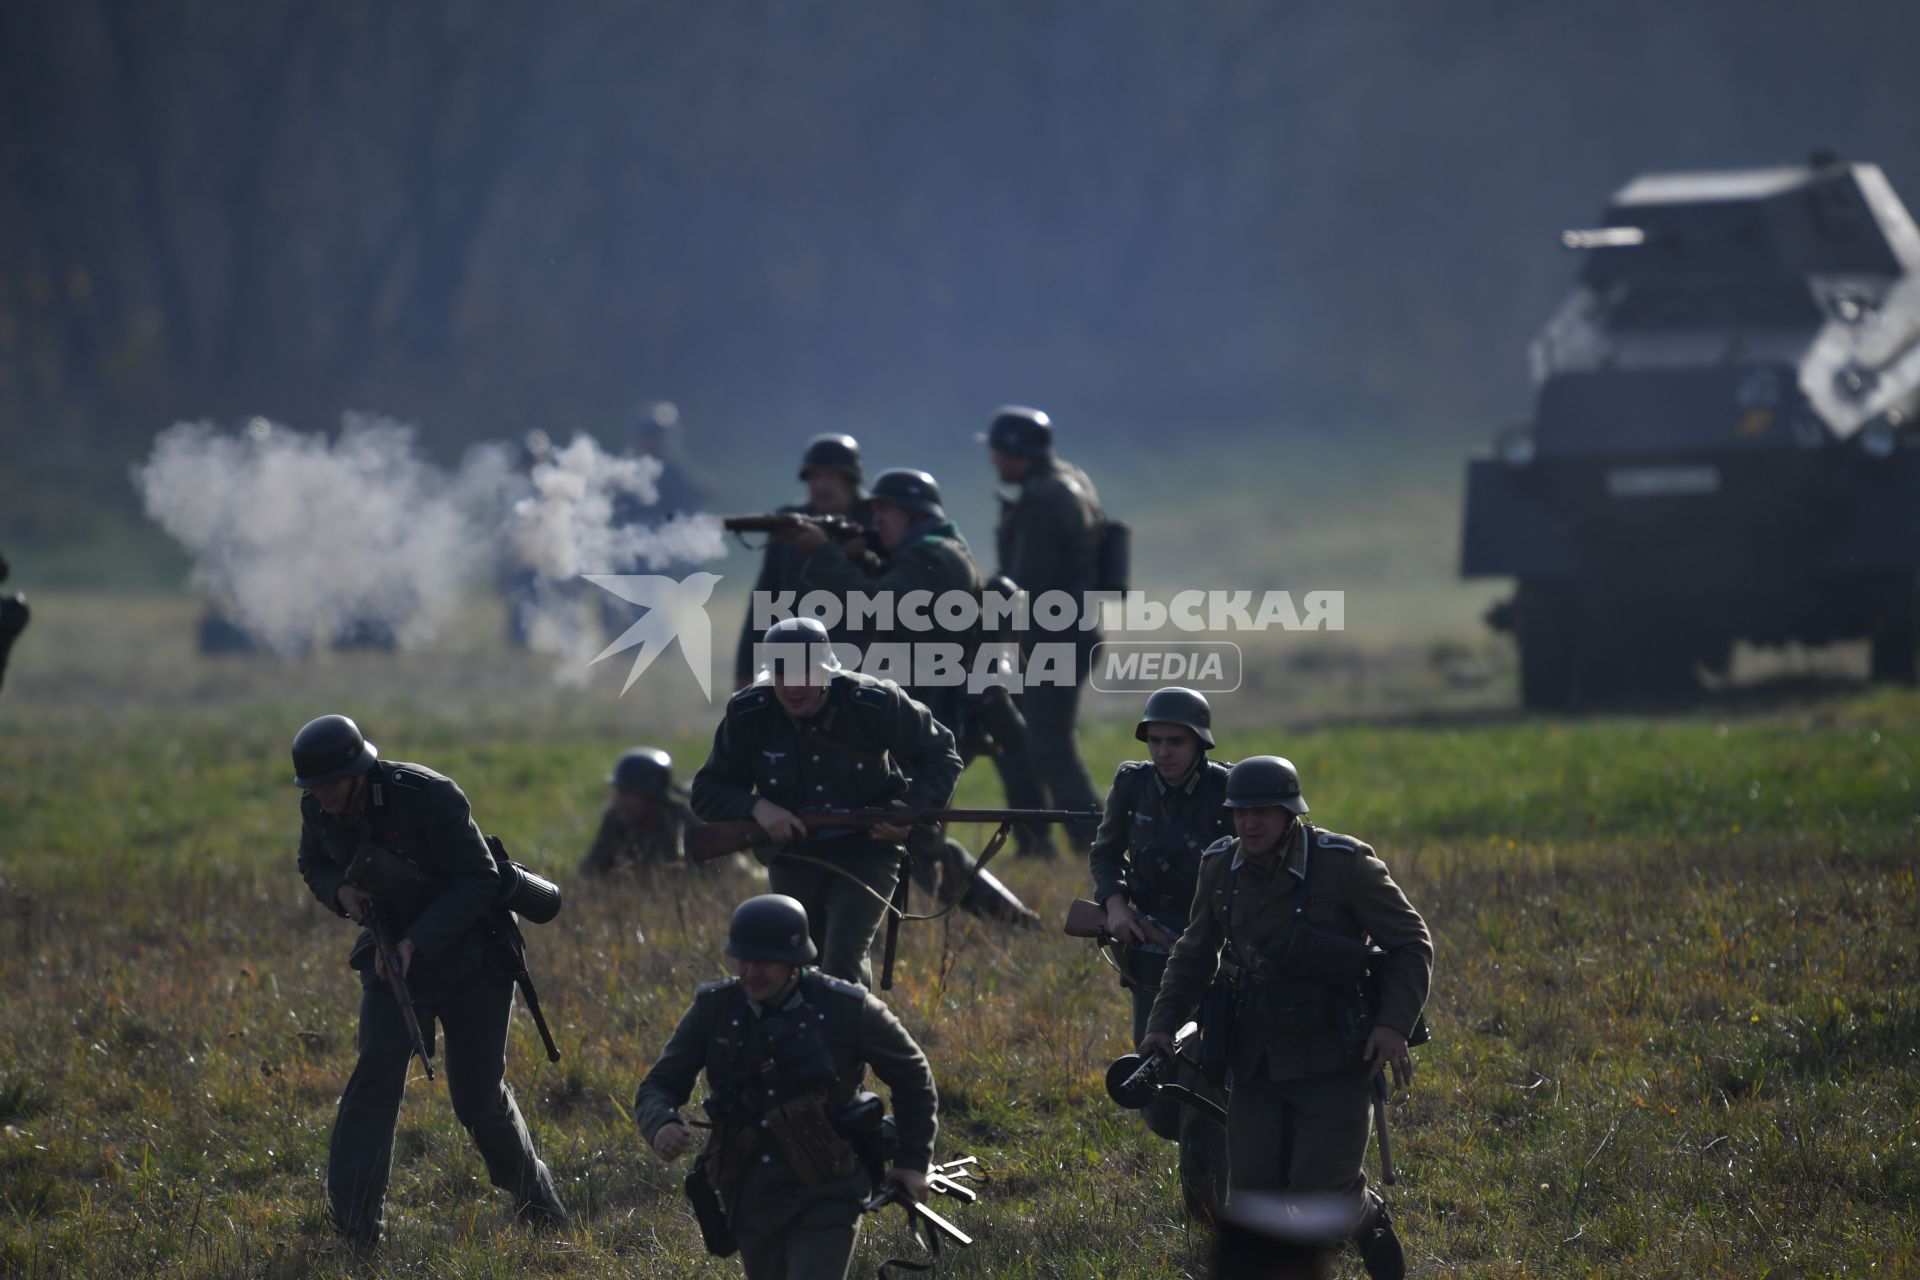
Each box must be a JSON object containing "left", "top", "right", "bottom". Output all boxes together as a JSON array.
[{"left": 1148, "top": 821, "right": 1432, "bottom": 1192}]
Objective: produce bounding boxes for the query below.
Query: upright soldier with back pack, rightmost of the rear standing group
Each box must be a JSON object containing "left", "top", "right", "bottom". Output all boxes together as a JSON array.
[{"left": 985, "top": 405, "right": 1106, "bottom": 844}]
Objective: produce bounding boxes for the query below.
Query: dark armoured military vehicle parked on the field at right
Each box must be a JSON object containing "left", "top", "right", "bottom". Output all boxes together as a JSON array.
[{"left": 1461, "top": 155, "right": 1920, "bottom": 708}]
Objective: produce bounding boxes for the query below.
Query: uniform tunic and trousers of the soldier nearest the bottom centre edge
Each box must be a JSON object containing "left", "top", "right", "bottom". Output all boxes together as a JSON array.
[{"left": 634, "top": 969, "right": 937, "bottom": 1280}]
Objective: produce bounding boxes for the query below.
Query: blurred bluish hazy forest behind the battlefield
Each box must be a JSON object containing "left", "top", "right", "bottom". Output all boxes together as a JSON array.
[{"left": 0, "top": 0, "right": 1920, "bottom": 585}]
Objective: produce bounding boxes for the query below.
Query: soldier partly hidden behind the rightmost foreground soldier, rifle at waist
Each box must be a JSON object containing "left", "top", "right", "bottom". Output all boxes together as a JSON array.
[{"left": 1087, "top": 687, "right": 1233, "bottom": 1217}]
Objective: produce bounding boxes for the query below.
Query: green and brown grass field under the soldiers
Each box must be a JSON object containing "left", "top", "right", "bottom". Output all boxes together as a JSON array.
[{"left": 0, "top": 599, "right": 1920, "bottom": 1278}]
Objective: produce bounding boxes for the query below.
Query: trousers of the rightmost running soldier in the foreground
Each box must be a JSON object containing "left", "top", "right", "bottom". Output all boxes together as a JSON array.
[{"left": 1227, "top": 1071, "right": 1373, "bottom": 1197}]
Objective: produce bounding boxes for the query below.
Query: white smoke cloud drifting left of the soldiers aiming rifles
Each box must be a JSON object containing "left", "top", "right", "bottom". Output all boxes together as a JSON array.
[{"left": 134, "top": 415, "right": 724, "bottom": 677}]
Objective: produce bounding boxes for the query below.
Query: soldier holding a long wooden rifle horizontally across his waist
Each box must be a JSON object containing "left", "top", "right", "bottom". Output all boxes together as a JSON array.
[{"left": 693, "top": 618, "right": 960, "bottom": 983}]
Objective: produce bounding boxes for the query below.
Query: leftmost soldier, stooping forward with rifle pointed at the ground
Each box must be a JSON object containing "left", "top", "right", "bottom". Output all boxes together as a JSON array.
[{"left": 294, "top": 716, "right": 566, "bottom": 1247}]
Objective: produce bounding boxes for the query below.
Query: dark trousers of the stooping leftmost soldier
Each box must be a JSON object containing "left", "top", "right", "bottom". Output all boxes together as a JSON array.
[{"left": 326, "top": 971, "right": 559, "bottom": 1244}]
